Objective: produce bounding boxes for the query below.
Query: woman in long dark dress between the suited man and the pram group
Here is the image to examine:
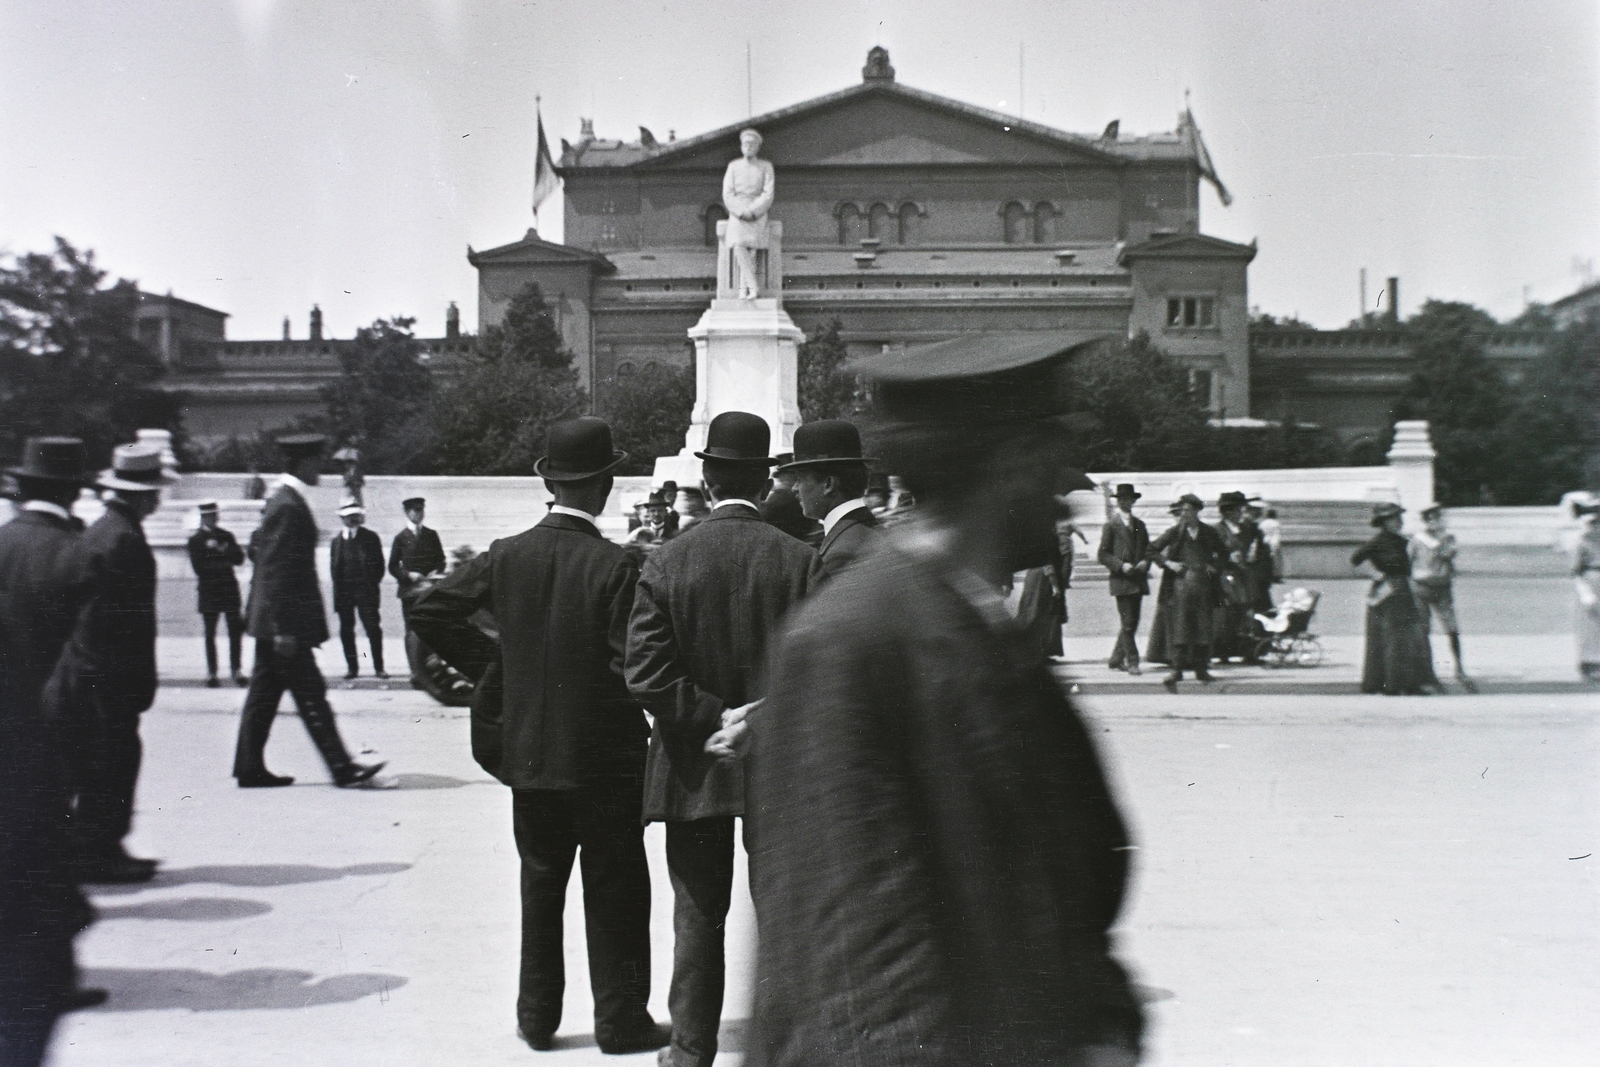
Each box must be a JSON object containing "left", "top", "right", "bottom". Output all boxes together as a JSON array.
[{"left": 1144, "top": 493, "right": 1227, "bottom": 693}]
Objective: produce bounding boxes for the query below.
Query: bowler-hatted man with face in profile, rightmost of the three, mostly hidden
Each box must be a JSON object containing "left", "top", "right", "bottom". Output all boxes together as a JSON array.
[{"left": 778, "top": 419, "right": 883, "bottom": 577}]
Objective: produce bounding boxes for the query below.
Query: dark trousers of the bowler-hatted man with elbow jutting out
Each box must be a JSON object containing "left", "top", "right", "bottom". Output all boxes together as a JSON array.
[{"left": 512, "top": 776, "right": 651, "bottom": 1048}]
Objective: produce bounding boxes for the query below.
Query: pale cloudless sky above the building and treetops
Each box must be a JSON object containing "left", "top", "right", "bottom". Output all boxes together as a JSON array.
[{"left": 0, "top": 0, "right": 1600, "bottom": 339}]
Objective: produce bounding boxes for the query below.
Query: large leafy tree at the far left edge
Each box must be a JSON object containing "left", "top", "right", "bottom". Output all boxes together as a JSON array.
[{"left": 0, "top": 237, "right": 184, "bottom": 464}]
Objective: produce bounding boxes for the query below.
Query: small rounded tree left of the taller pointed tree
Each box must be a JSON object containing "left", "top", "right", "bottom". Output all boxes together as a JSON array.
[{"left": 322, "top": 318, "right": 434, "bottom": 474}]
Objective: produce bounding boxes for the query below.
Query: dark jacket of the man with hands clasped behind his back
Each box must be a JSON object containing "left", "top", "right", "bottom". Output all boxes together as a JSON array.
[{"left": 626, "top": 504, "right": 822, "bottom": 821}]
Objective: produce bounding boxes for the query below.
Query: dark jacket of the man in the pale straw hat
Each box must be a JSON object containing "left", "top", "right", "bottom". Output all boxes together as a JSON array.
[{"left": 58, "top": 501, "right": 155, "bottom": 712}]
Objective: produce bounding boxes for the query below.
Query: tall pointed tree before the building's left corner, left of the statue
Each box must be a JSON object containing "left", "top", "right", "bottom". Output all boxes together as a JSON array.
[{"left": 430, "top": 282, "right": 589, "bottom": 475}]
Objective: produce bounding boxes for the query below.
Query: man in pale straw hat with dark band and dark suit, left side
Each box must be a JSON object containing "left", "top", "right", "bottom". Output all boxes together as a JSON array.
[{"left": 50, "top": 445, "right": 176, "bottom": 883}]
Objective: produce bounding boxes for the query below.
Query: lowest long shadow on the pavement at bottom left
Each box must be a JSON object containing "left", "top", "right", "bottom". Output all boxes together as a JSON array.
[{"left": 82, "top": 968, "right": 406, "bottom": 1011}]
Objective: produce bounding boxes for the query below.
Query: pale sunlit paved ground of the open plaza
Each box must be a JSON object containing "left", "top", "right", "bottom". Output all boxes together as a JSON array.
[{"left": 43, "top": 584, "right": 1600, "bottom": 1067}]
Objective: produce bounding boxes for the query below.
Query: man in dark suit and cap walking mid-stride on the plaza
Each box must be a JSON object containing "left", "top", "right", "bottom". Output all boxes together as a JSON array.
[{"left": 234, "top": 434, "right": 384, "bottom": 789}]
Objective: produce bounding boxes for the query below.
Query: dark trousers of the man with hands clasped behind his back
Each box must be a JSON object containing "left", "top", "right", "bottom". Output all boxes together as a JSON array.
[{"left": 667, "top": 816, "right": 733, "bottom": 1067}]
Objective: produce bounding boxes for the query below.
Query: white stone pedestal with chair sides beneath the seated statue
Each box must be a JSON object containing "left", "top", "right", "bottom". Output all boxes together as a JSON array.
[{"left": 653, "top": 221, "right": 805, "bottom": 485}]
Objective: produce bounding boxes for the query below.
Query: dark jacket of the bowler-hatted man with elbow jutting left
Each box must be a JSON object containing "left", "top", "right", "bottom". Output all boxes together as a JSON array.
[{"left": 411, "top": 515, "right": 650, "bottom": 789}]
